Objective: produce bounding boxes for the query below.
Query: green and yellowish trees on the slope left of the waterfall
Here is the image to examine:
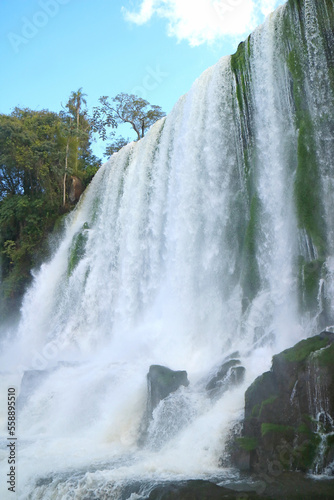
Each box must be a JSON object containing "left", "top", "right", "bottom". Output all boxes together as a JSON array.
[{"left": 0, "top": 88, "right": 164, "bottom": 318}]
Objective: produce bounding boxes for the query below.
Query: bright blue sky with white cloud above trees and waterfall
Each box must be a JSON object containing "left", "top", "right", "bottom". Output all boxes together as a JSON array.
[{"left": 0, "top": 0, "right": 284, "bottom": 157}]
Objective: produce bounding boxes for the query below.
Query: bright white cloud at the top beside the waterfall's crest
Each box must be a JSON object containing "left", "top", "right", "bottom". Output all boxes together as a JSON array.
[{"left": 122, "top": 0, "right": 283, "bottom": 46}]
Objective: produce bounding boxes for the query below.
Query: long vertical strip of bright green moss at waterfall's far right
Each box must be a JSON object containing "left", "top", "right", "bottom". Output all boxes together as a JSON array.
[{"left": 281, "top": 0, "right": 334, "bottom": 313}]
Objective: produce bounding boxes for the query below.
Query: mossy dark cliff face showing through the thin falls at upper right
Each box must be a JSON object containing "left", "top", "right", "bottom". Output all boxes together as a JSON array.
[{"left": 231, "top": 0, "right": 334, "bottom": 324}]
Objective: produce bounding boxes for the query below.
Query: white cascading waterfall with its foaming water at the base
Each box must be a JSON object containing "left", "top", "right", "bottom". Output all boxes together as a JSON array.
[{"left": 0, "top": 0, "right": 334, "bottom": 500}]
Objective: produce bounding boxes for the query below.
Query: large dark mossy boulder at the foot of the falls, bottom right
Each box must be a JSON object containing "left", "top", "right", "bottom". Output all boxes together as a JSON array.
[{"left": 234, "top": 332, "right": 334, "bottom": 474}]
